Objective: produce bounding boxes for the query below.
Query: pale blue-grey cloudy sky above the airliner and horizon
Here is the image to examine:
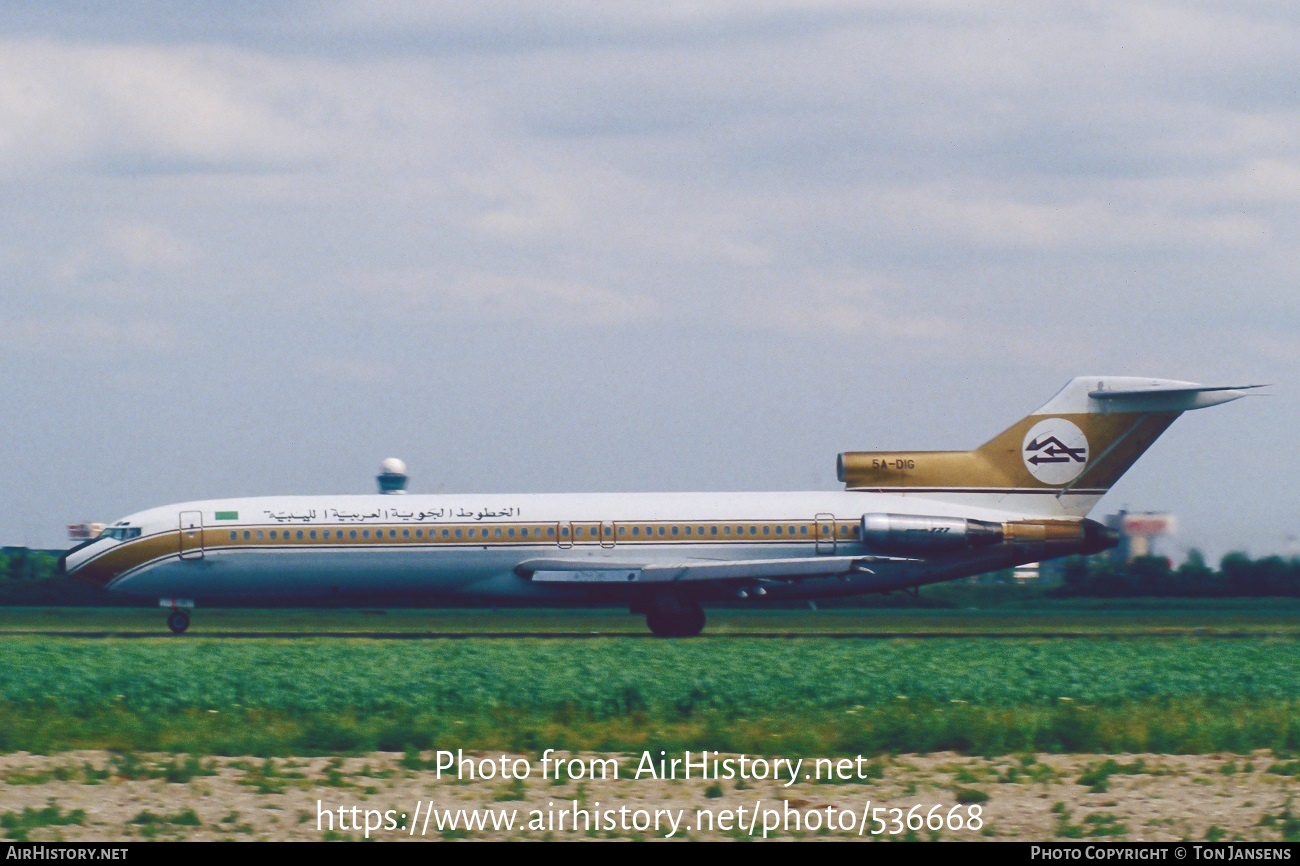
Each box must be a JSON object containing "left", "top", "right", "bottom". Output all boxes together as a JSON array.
[{"left": 0, "top": 0, "right": 1300, "bottom": 558}]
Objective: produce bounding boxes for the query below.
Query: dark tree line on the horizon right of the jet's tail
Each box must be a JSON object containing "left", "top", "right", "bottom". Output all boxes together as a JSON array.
[{"left": 1048, "top": 550, "right": 1300, "bottom": 598}]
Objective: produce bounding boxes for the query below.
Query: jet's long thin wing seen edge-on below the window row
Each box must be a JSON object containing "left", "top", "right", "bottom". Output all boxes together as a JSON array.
[{"left": 515, "top": 557, "right": 914, "bottom": 584}]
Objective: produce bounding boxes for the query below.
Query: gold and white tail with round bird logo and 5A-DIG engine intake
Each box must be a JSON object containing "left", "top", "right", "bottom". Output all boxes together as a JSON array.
[{"left": 839, "top": 376, "right": 1261, "bottom": 516}]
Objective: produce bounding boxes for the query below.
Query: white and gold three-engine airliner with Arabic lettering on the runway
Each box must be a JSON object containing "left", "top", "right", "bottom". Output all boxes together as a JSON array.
[{"left": 59, "top": 376, "right": 1261, "bottom": 637}]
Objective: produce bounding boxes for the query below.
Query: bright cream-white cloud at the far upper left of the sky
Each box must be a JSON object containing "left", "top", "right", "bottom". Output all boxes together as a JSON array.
[{"left": 0, "top": 39, "right": 322, "bottom": 173}]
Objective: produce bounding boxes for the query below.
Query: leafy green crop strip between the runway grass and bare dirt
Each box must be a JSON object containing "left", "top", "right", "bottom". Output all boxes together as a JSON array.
[{"left": 0, "top": 636, "right": 1300, "bottom": 754}]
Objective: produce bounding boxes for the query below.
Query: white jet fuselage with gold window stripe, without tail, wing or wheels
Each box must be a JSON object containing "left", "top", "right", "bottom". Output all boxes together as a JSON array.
[{"left": 65, "top": 492, "right": 1073, "bottom": 602}]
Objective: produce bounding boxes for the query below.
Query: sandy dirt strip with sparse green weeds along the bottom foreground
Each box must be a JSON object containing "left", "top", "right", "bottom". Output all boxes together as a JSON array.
[{"left": 0, "top": 752, "right": 1300, "bottom": 841}]
